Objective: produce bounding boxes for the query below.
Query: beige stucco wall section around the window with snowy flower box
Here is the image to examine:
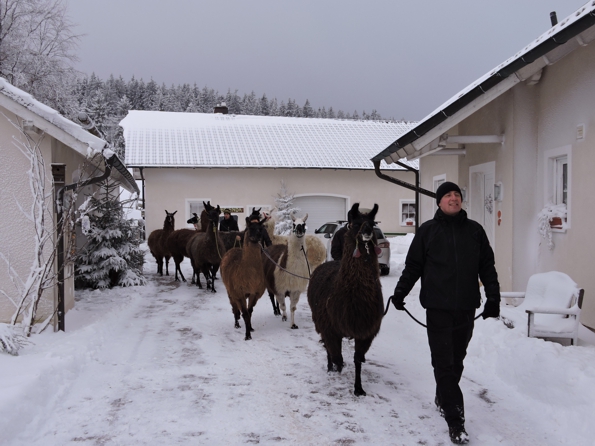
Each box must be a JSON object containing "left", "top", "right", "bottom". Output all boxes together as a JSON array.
[{"left": 536, "top": 44, "right": 595, "bottom": 328}]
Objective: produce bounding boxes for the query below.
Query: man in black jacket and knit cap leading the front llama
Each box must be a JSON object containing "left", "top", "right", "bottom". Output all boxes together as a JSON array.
[{"left": 392, "top": 182, "right": 500, "bottom": 444}]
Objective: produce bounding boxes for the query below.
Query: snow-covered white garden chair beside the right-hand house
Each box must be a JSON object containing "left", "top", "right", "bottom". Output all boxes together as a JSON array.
[{"left": 500, "top": 271, "right": 584, "bottom": 345}]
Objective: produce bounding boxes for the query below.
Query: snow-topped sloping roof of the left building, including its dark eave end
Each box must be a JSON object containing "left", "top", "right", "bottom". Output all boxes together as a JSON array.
[{"left": 0, "top": 77, "right": 140, "bottom": 193}]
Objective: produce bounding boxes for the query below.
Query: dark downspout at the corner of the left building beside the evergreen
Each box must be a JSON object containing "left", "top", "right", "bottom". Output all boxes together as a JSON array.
[{"left": 55, "top": 156, "right": 116, "bottom": 331}]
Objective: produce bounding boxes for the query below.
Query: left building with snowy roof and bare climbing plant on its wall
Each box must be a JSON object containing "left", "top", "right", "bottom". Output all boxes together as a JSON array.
[{"left": 0, "top": 78, "right": 138, "bottom": 325}]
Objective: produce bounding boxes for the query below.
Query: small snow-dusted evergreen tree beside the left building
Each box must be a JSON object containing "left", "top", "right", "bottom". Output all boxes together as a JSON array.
[{"left": 75, "top": 180, "right": 146, "bottom": 288}]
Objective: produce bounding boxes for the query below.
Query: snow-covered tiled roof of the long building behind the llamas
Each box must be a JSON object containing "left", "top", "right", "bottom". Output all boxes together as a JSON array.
[{"left": 120, "top": 110, "right": 417, "bottom": 170}]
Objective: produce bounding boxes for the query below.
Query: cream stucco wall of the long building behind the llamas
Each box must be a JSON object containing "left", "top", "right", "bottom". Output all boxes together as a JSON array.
[{"left": 143, "top": 168, "right": 415, "bottom": 234}]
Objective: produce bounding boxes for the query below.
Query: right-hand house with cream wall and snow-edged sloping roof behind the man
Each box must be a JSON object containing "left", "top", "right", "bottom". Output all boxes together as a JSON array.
[{"left": 373, "top": 0, "right": 595, "bottom": 329}]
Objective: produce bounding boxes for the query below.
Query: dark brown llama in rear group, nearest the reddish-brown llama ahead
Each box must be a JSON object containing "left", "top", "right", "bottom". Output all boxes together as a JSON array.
[{"left": 186, "top": 203, "right": 225, "bottom": 293}]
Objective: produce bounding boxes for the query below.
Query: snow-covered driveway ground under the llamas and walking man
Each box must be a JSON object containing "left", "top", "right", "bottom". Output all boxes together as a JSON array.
[{"left": 0, "top": 237, "right": 595, "bottom": 446}]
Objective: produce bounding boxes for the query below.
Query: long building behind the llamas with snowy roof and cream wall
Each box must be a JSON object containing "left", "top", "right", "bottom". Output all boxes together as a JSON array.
[{"left": 120, "top": 111, "right": 417, "bottom": 234}]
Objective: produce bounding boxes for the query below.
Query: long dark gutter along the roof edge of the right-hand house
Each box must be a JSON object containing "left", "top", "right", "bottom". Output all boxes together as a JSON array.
[{"left": 372, "top": 7, "right": 595, "bottom": 163}]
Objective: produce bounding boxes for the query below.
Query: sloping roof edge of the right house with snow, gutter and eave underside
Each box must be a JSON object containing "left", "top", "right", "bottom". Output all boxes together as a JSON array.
[{"left": 372, "top": 0, "right": 595, "bottom": 163}]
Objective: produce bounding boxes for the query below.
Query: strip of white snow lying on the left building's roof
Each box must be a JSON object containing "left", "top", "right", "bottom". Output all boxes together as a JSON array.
[{"left": 0, "top": 77, "right": 106, "bottom": 156}]
